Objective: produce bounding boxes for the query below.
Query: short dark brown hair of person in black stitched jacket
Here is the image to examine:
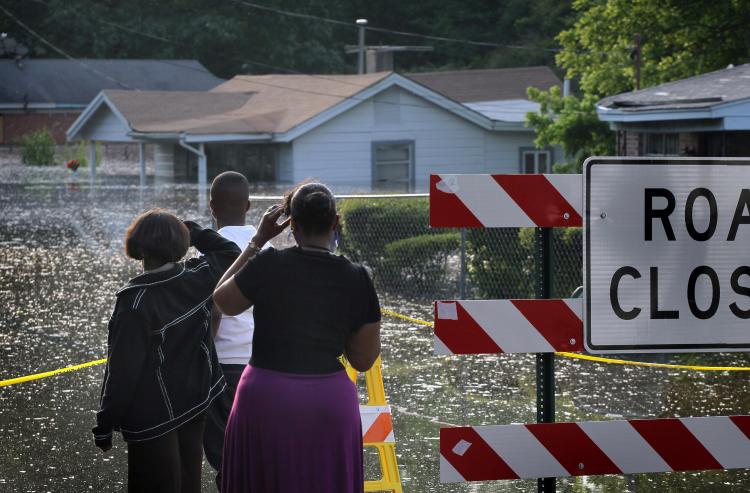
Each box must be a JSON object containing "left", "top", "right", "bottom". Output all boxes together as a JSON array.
[{"left": 125, "top": 209, "right": 190, "bottom": 263}]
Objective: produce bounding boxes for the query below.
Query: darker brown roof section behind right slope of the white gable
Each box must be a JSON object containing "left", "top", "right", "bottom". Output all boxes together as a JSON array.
[{"left": 407, "top": 67, "right": 561, "bottom": 103}]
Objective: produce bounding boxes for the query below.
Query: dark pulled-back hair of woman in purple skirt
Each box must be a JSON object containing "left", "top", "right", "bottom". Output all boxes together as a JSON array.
[{"left": 284, "top": 182, "right": 336, "bottom": 235}]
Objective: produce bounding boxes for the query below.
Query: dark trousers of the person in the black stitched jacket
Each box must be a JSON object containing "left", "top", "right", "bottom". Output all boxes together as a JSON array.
[{"left": 128, "top": 414, "right": 206, "bottom": 493}]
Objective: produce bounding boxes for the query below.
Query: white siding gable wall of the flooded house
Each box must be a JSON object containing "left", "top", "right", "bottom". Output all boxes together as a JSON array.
[{"left": 290, "top": 87, "right": 534, "bottom": 191}]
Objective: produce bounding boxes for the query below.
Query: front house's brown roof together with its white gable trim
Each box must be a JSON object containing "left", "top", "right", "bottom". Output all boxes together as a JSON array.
[{"left": 68, "top": 72, "right": 506, "bottom": 142}]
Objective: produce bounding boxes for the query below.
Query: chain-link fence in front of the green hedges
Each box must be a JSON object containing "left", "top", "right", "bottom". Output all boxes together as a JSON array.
[{"left": 249, "top": 195, "right": 583, "bottom": 302}]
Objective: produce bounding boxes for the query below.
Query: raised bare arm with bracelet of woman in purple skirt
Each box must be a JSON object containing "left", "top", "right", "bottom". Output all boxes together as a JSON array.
[{"left": 214, "top": 204, "right": 291, "bottom": 315}]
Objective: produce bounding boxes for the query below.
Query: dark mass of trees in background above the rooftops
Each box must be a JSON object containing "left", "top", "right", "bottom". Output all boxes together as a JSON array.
[{"left": 0, "top": 0, "right": 572, "bottom": 77}]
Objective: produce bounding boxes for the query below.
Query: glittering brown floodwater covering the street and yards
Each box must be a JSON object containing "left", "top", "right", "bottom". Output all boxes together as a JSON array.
[{"left": 0, "top": 170, "right": 750, "bottom": 493}]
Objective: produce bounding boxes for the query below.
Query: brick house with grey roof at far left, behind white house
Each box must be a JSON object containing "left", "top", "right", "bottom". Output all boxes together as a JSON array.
[{"left": 0, "top": 59, "right": 224, "bottom": 145}]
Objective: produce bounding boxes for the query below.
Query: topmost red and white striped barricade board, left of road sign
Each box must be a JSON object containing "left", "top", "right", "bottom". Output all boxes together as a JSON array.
[{"left": 430, "top": 174, "right": 583, "bottom": 228}]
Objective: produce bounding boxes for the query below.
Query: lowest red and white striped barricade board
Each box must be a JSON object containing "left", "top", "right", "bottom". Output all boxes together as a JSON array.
[{"left": 440, "top": 416, "right": 750, "bottom": 483}]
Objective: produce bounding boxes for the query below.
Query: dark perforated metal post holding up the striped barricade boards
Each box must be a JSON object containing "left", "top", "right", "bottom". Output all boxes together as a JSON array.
[{"left": 535, "top": 228, "right": 557, "bottom": 493}]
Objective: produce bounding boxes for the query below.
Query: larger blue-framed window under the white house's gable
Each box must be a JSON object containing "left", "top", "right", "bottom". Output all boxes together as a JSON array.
[{"left": 372, "top": 141, "right": 414, "bottom": 193}]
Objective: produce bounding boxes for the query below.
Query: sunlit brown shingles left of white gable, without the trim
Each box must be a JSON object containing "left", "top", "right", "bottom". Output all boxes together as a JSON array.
[{"left": 105, "top": 72, "right": 390, "bottom": 134}]
